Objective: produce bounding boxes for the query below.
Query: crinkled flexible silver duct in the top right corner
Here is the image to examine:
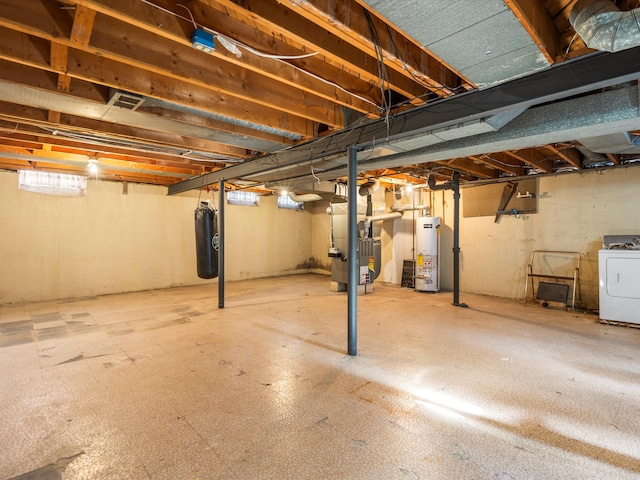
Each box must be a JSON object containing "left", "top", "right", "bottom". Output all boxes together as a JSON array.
[{"left": 569, "top": 0, "right": 640, "bottom": 52}]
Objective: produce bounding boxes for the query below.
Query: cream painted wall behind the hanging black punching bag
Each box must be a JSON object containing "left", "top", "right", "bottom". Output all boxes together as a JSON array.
[{"left": 0, "top": 172, "right": 312, "bottom": 303}]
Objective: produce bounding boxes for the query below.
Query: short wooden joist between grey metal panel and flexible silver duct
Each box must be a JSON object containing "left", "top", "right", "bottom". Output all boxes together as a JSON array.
[{"left": 504, "top": 0, "right": 561, "bottom": 65}]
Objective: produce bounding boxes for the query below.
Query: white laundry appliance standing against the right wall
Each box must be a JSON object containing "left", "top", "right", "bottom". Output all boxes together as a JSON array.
[{"left": 598, "top": 249, "right": 640, "bottom": 324}]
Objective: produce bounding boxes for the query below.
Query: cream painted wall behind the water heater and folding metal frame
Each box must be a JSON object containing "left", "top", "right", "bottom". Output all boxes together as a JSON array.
[{"left": 382, "top": 166, "right": 640, "bottom": 308}]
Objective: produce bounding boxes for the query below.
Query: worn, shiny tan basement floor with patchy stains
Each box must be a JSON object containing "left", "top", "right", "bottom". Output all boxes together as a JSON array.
[{"left": 0, "top": 275, "right": 640, "bottom": 480}]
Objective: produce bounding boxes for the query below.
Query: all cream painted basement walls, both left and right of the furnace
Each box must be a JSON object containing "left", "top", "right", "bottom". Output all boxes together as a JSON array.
[{"left": 8, "top": 166, "right": 640, "bottom": 308}]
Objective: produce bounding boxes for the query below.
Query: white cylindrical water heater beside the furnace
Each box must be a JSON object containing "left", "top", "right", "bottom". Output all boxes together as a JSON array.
[{"left": 415, "top": 217, "right": 440, "bottom": 292}]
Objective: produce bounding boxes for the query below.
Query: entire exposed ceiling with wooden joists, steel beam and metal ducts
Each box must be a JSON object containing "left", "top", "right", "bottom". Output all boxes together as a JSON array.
[{"left": 0, "top": 0, "right": 640, "bottom": 194}]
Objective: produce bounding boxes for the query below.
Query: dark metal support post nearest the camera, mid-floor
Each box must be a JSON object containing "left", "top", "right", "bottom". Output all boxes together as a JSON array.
[{"left": 347, "top": 147, "right": 358, "bottom": 356}]
